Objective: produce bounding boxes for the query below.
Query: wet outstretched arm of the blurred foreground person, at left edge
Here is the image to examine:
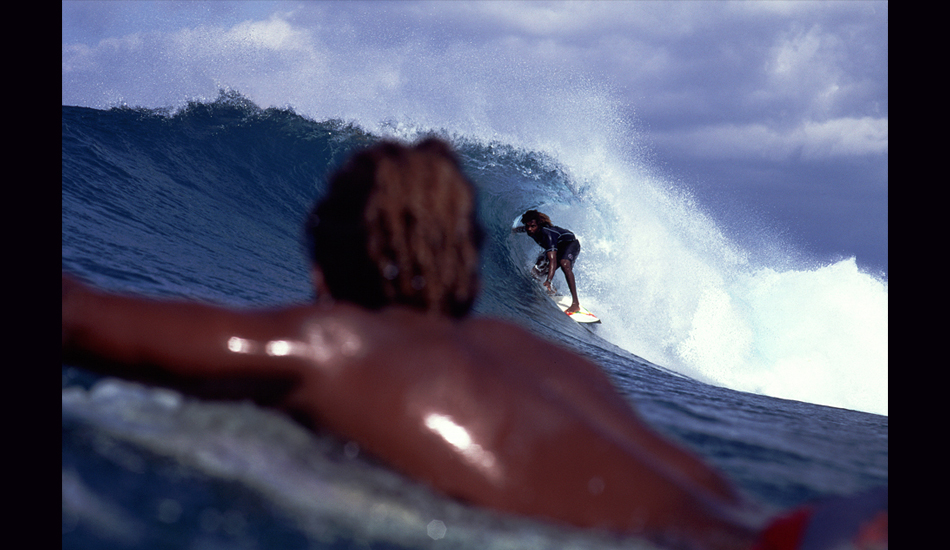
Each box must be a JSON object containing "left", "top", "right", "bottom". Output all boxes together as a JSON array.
[{"left": 62, "top": 275, "right": 304, "bottom": 402}]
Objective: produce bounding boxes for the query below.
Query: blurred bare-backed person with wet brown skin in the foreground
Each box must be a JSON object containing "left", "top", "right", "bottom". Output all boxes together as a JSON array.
[{"left": 62, "top": 139, "right": 888, "bottom": 549}]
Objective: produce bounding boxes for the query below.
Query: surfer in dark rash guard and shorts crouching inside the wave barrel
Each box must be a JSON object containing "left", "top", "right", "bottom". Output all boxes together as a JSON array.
[{"left": 513, "top": 210, "right": 581, "bottom": 315}]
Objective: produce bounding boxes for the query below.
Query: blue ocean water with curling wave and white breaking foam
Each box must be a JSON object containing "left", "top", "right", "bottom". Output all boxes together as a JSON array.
[{"left": 62, "top": 94, "right": 888, "bottom": 549}]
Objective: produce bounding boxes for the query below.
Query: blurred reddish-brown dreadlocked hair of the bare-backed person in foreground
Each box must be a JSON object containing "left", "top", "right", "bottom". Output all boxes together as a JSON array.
[{"left": 307, "top": 138, "right": 482, "bottom": 317}]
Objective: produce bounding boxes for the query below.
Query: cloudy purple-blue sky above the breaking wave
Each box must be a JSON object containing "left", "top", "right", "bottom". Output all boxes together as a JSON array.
[{"left": 62, "top": 0, "right": 888, "bottom": 273}]
